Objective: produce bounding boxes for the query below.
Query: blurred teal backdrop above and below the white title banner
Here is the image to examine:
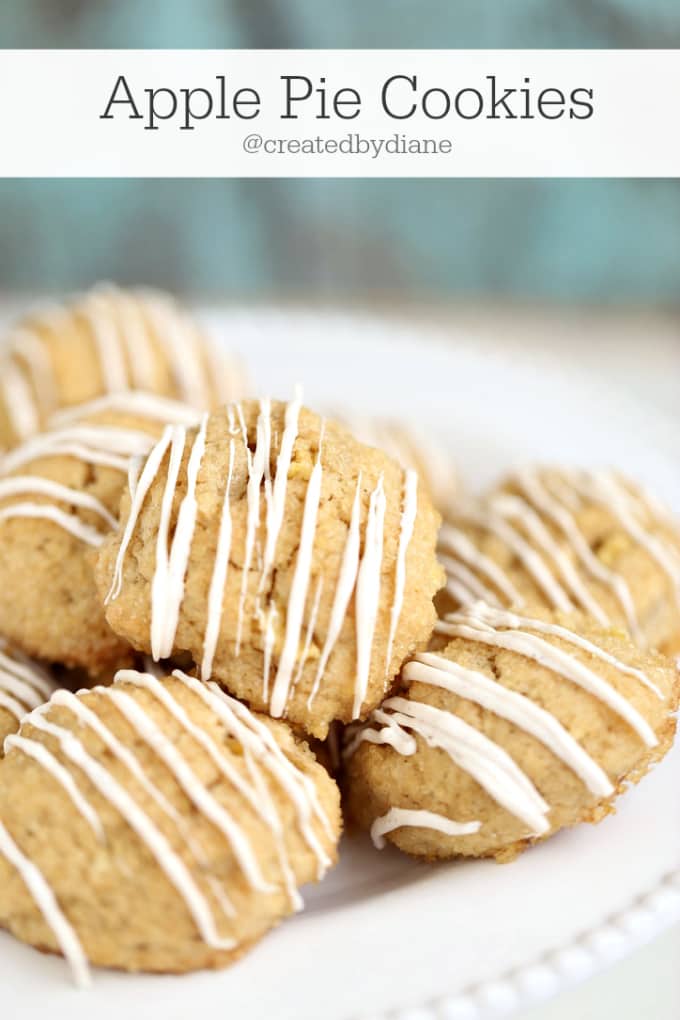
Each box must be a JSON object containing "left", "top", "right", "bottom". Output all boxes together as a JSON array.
[{"left": 0, "top": 0, "right": 680, "bottom": 306}]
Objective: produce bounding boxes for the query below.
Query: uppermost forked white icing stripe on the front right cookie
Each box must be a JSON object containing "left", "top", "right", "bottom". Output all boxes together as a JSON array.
[{"left": 437, "top": 603, "right": 659, "bottom": 748}]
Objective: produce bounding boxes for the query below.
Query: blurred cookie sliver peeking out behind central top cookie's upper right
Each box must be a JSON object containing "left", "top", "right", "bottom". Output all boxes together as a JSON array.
[{"left": 333, "top": 414, "right": 461, "bottom": 519}]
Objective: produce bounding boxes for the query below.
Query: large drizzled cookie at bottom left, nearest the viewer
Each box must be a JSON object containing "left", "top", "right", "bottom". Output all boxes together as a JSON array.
[{"left": 0, "top": 671, "right": 342, "bottom": 981}]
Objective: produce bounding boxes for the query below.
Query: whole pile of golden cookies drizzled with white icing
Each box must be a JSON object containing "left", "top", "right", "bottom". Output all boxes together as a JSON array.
[{"left": 0, "top": 288, "right": 680, "bottom": 981}]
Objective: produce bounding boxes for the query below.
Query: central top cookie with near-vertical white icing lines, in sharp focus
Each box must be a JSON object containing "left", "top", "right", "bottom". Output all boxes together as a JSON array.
[{"left": 97, "top": 400, "right": 442, "bottom": 738}]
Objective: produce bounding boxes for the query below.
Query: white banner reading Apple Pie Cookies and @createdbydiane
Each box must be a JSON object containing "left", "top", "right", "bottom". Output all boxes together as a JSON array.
[{"left": 0, "top": 50, "right": 680, "bottom": 177}]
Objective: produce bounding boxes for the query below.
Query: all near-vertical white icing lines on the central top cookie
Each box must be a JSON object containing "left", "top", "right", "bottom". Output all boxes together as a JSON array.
[{"left": 106, "top": 395, "right": 417, "bottom": 717}]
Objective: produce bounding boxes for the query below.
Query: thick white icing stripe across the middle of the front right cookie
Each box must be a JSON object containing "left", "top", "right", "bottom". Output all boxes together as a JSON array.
[{"left": 404, "top": 653, "right": 614, "bottom": 797}]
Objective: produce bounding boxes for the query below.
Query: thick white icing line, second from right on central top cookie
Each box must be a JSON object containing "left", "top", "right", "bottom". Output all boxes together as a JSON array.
[{"left": 352, "top": 475, "right": 385, "bottom": 719}]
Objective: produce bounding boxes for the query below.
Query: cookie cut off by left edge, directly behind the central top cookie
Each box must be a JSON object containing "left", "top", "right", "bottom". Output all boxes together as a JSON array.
[{"left": 0, "top": 393, "right": 196, "bottom": 674}]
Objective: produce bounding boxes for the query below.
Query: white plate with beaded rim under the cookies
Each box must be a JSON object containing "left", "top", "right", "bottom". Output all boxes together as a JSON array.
[{"left": 0, "top": 311, "right": 680, "bottom": 1020}]
